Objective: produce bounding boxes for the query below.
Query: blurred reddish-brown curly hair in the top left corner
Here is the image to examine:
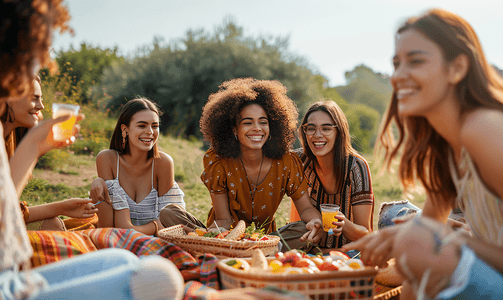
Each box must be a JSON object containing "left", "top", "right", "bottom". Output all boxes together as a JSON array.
[{"left": 0, "top": 0, "right": 72, "bottom": 98}]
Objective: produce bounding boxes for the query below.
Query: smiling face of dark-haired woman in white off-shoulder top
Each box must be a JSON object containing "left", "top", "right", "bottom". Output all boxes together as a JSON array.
[{"left": 121, "top": 110, "right": 159, "bottom": 151}]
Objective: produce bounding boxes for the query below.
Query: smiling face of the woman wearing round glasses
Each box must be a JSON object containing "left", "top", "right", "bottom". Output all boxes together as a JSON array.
[{"left": 303, "top": 110, "right": 338, "bottom": 157}]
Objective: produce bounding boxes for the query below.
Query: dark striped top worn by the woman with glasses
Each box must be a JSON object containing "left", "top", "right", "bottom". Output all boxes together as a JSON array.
[{"left": 293, "top": 148, "right": 374, "bottom": 248}]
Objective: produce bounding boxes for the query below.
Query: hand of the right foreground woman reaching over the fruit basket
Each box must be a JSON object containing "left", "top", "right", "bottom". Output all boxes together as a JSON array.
[{"left": 341, "top": 225, "right": 403, "bottom": 268}]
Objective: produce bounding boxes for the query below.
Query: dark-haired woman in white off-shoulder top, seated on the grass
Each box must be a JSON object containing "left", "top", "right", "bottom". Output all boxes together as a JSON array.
[{"left": 91, "top": 98, "right": 185, "bottom": 235}]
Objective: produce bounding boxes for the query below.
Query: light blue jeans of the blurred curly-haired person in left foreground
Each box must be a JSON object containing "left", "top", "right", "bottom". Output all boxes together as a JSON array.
[{"left": 0, "top": 249, "right": 163, "bottom": 300}]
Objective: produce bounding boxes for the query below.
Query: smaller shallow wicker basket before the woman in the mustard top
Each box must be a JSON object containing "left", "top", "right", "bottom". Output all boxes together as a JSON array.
[{"left": 157, "top": 225, "right": 280, "bottom": 258}]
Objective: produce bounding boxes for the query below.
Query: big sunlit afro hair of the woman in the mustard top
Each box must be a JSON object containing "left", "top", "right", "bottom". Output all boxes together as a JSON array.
[{"left": 199, "top": 78, "right": 299, "bottom": 159}]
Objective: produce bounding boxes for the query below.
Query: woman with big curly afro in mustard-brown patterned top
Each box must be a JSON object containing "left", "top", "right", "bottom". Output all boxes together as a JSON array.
[{"left": 163, "top": 78, "right": 321, "bottom": 248}]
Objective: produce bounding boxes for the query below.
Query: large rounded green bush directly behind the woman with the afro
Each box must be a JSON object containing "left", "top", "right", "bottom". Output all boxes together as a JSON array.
[{"left": 101, "top": 19, "right": 320, "bottom": 137}]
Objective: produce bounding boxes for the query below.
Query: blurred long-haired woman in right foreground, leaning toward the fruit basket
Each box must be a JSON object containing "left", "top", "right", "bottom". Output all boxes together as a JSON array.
[{"left": 342, "top": 9, "right": 503, "bottom": 299}]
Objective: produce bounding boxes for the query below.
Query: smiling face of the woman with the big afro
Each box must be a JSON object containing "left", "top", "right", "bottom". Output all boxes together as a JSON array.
[{"left": 234, "top": 104, "right": 269, "bottom": 151}]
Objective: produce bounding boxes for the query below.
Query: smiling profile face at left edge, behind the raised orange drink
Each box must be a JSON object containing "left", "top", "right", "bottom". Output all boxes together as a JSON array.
[{"left": 9, "top": 80, "right": 44, "bottom": 128}]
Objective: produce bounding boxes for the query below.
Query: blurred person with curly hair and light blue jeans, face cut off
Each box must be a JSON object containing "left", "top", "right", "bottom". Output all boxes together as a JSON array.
[{"left": 0, "top": 0, "right": 183, "bottom": 299}]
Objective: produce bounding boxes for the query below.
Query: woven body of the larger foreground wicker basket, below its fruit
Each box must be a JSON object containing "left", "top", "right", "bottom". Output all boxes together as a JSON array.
[{"left": 217, "top": 257, "right": 377, "bottom": 300}]
